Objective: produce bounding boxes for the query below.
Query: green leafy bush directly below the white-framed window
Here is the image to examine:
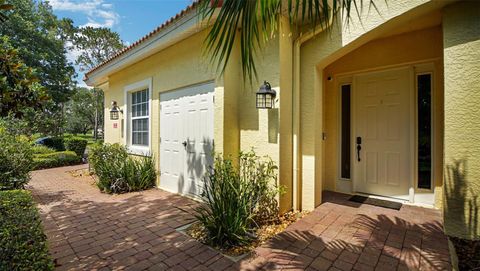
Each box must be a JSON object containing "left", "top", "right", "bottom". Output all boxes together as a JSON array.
[{"left": 89, "top": 144, "right": 157, "bottom": 193}]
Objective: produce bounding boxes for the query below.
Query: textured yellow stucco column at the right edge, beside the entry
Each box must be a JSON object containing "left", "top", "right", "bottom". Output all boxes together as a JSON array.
[{"left": 443, "top": 1, "right": 480, "bottom": 239}]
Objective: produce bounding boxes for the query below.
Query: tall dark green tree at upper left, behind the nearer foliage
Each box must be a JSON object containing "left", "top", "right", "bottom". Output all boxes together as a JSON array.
[{"left": 0, "top": 0, "right": 75, "bottom": 105}]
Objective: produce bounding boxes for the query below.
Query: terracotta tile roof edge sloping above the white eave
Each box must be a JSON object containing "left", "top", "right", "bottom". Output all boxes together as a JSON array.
[{"left": 83, "top": 0, "right": 200, "bottom": 81}]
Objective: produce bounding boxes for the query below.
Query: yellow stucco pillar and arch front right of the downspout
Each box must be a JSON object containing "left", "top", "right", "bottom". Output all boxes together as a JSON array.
[{"left": 299, "top": 0, "right": 445, "bottom": 209}]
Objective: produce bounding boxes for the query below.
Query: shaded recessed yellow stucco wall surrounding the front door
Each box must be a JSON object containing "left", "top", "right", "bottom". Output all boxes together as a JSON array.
[{"left": 323, "top": 26, "right": 443, "bottom": 207}]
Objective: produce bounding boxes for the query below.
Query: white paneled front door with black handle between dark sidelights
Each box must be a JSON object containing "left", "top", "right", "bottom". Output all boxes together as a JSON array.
[{"left": 352, "top": 68, "right": 413, "bottom": 199}]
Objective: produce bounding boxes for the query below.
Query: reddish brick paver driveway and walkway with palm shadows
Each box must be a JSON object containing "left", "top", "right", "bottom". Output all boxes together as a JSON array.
[{"left": 30, "top": 166, "right": 451, "bottom": 270}]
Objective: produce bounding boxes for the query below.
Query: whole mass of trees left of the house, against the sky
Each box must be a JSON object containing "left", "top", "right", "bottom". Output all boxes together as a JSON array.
[{"left": 0, "top": 0, "right": 123, "bottom": 134}]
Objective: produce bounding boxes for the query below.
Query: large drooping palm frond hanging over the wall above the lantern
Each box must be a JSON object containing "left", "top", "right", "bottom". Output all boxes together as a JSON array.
[{"left": 199, "top": 0, "right": 280, "bottom": 83}]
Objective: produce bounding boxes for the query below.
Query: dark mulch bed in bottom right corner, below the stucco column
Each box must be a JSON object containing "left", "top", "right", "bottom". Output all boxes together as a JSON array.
[{"left": 449, "top": 237, "right": 480, "bottom": 270}]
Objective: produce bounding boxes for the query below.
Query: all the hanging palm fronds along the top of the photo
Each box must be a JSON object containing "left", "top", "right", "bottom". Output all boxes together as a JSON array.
[{"left": 198, "top": 0, "right": 376, "bottom": 81}]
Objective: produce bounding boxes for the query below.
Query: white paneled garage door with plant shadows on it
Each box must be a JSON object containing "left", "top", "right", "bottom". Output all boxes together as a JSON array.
[{"left": 160, "top": 83, "right": 214, "bottom": 199}]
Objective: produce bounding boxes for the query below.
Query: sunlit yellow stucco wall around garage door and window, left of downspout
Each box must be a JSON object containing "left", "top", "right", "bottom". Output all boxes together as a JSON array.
[{"left": 100, "top": 26, "right": 288, "bottom": 193}]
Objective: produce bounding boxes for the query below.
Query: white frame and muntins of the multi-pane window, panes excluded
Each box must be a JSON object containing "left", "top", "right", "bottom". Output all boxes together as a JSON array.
[{"left": 124, "top": 77, "right": 152, "bottom": 156}]
